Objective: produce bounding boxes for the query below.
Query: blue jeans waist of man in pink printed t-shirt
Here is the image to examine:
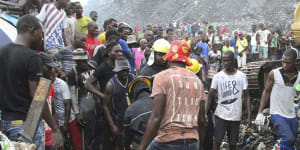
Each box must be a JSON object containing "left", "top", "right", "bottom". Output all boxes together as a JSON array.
[{"left": 146, "top": 139, "right": 199, "bottom": 150}]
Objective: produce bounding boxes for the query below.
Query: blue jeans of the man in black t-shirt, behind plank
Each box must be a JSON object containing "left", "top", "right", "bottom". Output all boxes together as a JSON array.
[{"left": 1, "top": 120, "right": 45, "bottom": 150}]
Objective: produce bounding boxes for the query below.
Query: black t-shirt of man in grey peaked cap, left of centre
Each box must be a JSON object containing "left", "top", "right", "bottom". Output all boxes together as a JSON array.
[{"left": 67, "top": 65, "right": 89, "bottom": 98}]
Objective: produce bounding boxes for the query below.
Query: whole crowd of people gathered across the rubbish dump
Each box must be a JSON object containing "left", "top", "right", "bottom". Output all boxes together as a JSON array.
[{"left": 0, "top": 0, "right": 300, "bottom": 150}]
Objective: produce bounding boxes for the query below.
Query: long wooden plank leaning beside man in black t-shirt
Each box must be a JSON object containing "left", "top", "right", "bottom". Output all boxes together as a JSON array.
[{"left": 20, "top": 78, "right": 51, "bottom": 143}]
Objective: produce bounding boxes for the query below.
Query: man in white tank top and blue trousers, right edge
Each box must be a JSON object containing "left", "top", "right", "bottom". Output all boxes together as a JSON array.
[{"left": 256, "top": 49, "right": 300, "bottom": 150}]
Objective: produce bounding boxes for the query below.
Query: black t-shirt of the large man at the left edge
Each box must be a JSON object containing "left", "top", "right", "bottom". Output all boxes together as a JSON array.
[{"left": 0, "top": 43, "right": 42, "bottom": 120}]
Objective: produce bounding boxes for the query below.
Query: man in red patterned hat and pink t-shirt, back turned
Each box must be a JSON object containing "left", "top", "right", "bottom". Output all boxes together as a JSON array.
[{"left": 138, "top": 41, "right": 205, "bottom": 150}]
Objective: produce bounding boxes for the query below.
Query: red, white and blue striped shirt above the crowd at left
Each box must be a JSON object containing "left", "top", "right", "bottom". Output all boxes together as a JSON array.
[{"left": 37, "top": 3, "right": 67, "bottom": 49}]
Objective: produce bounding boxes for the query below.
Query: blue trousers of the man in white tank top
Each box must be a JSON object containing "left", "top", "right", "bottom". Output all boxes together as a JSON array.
[{"left": 272, "top": 115, "right": 298, "bottom": 150}]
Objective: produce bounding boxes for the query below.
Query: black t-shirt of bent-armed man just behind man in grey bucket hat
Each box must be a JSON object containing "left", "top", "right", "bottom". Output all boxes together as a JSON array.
[{"left": 93, "top": 61, "right": 115, "bottom": 93}]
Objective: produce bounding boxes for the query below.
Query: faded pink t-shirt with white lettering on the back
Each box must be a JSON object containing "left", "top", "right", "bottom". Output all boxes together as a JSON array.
[{"left": 151, "top": 67, "right": 205, "bottom": 143}]
